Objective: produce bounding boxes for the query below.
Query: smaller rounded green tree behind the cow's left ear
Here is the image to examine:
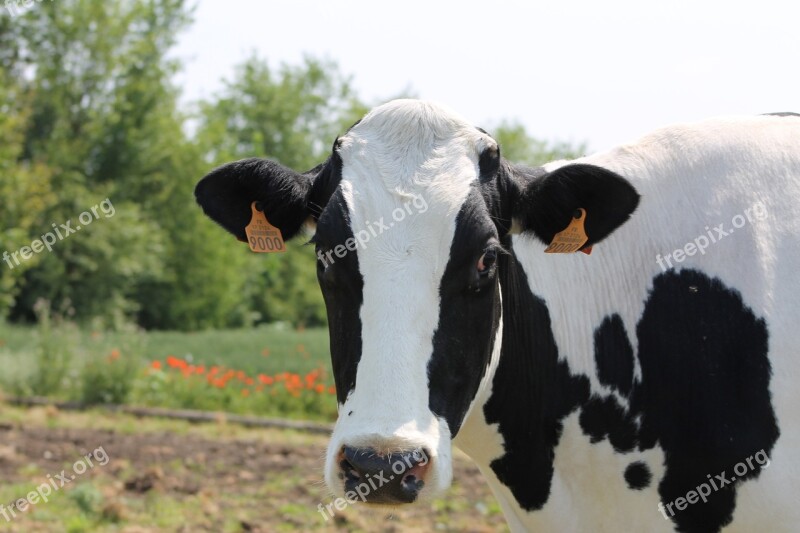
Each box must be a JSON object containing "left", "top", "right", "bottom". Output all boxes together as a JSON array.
[{"left": 198, "top": 56, "right": 366, "bottom": 325}]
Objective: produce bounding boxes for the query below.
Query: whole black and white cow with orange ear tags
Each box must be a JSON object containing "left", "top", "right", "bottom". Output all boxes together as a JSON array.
[{"left": 196, "top": 100, "right": 800, "bottom": 532}]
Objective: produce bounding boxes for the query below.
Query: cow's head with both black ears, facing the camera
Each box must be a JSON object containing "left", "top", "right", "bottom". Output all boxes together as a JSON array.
[{"left": 196, "top": 100, "right": 638, "bottom": 503}]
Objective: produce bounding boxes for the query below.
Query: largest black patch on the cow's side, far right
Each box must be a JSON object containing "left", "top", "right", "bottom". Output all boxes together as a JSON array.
[{"left": 632, "top": 270, "right": 779, "bottom": 531}]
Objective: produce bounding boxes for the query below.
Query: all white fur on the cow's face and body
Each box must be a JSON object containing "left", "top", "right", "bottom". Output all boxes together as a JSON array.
[{"left": 326, "top": 100, "right": 800, "bottom": 531}]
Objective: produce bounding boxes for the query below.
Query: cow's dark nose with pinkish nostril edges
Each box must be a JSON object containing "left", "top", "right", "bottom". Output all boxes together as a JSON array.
[{"left": 339, "top": 446, "right": 430, "bottom": 504}]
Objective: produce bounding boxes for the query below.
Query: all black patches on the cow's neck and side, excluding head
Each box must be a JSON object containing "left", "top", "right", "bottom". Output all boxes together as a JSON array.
[{"left": 485, "top": 262, "right": 779, "bottom": 531}]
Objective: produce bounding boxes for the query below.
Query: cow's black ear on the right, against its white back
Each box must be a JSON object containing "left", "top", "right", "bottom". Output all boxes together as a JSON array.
[{"left": 513, "top": 164, "right": 639, "bottom": 246}]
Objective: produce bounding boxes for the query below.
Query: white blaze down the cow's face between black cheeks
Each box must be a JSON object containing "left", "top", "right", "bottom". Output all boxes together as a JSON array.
[{"left": 325, "top": 100, "right": 496, "bottom": 494}]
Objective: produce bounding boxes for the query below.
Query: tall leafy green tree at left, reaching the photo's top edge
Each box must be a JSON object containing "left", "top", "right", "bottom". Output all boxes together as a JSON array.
[{"left": 0, "top": 0, "right": 188, "bottom": 321}]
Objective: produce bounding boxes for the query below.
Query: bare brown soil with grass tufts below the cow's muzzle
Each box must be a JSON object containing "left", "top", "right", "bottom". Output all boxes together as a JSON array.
[{"left": 0, "top": 405, "right": 507, "bottom": 533}]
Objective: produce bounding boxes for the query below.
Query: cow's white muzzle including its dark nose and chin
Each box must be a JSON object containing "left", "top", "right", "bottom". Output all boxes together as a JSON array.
[{"left": 325, "top": 414, "right": 453, "bottom": 506}]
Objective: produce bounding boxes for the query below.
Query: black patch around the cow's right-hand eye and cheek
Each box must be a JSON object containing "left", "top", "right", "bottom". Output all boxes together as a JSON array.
[{"left": 428, "top": 189, "right": 500, "bottom": 437}]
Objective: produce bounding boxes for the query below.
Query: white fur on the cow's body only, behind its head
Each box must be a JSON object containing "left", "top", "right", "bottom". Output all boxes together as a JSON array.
[{"left": 460, "top": 112, "right": 800, "bottom": 532}]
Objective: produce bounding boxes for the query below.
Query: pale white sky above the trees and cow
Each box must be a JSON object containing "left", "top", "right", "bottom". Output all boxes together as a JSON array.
[{"left": 176, "top": 0, "right": 800, "bottom": 152}]
